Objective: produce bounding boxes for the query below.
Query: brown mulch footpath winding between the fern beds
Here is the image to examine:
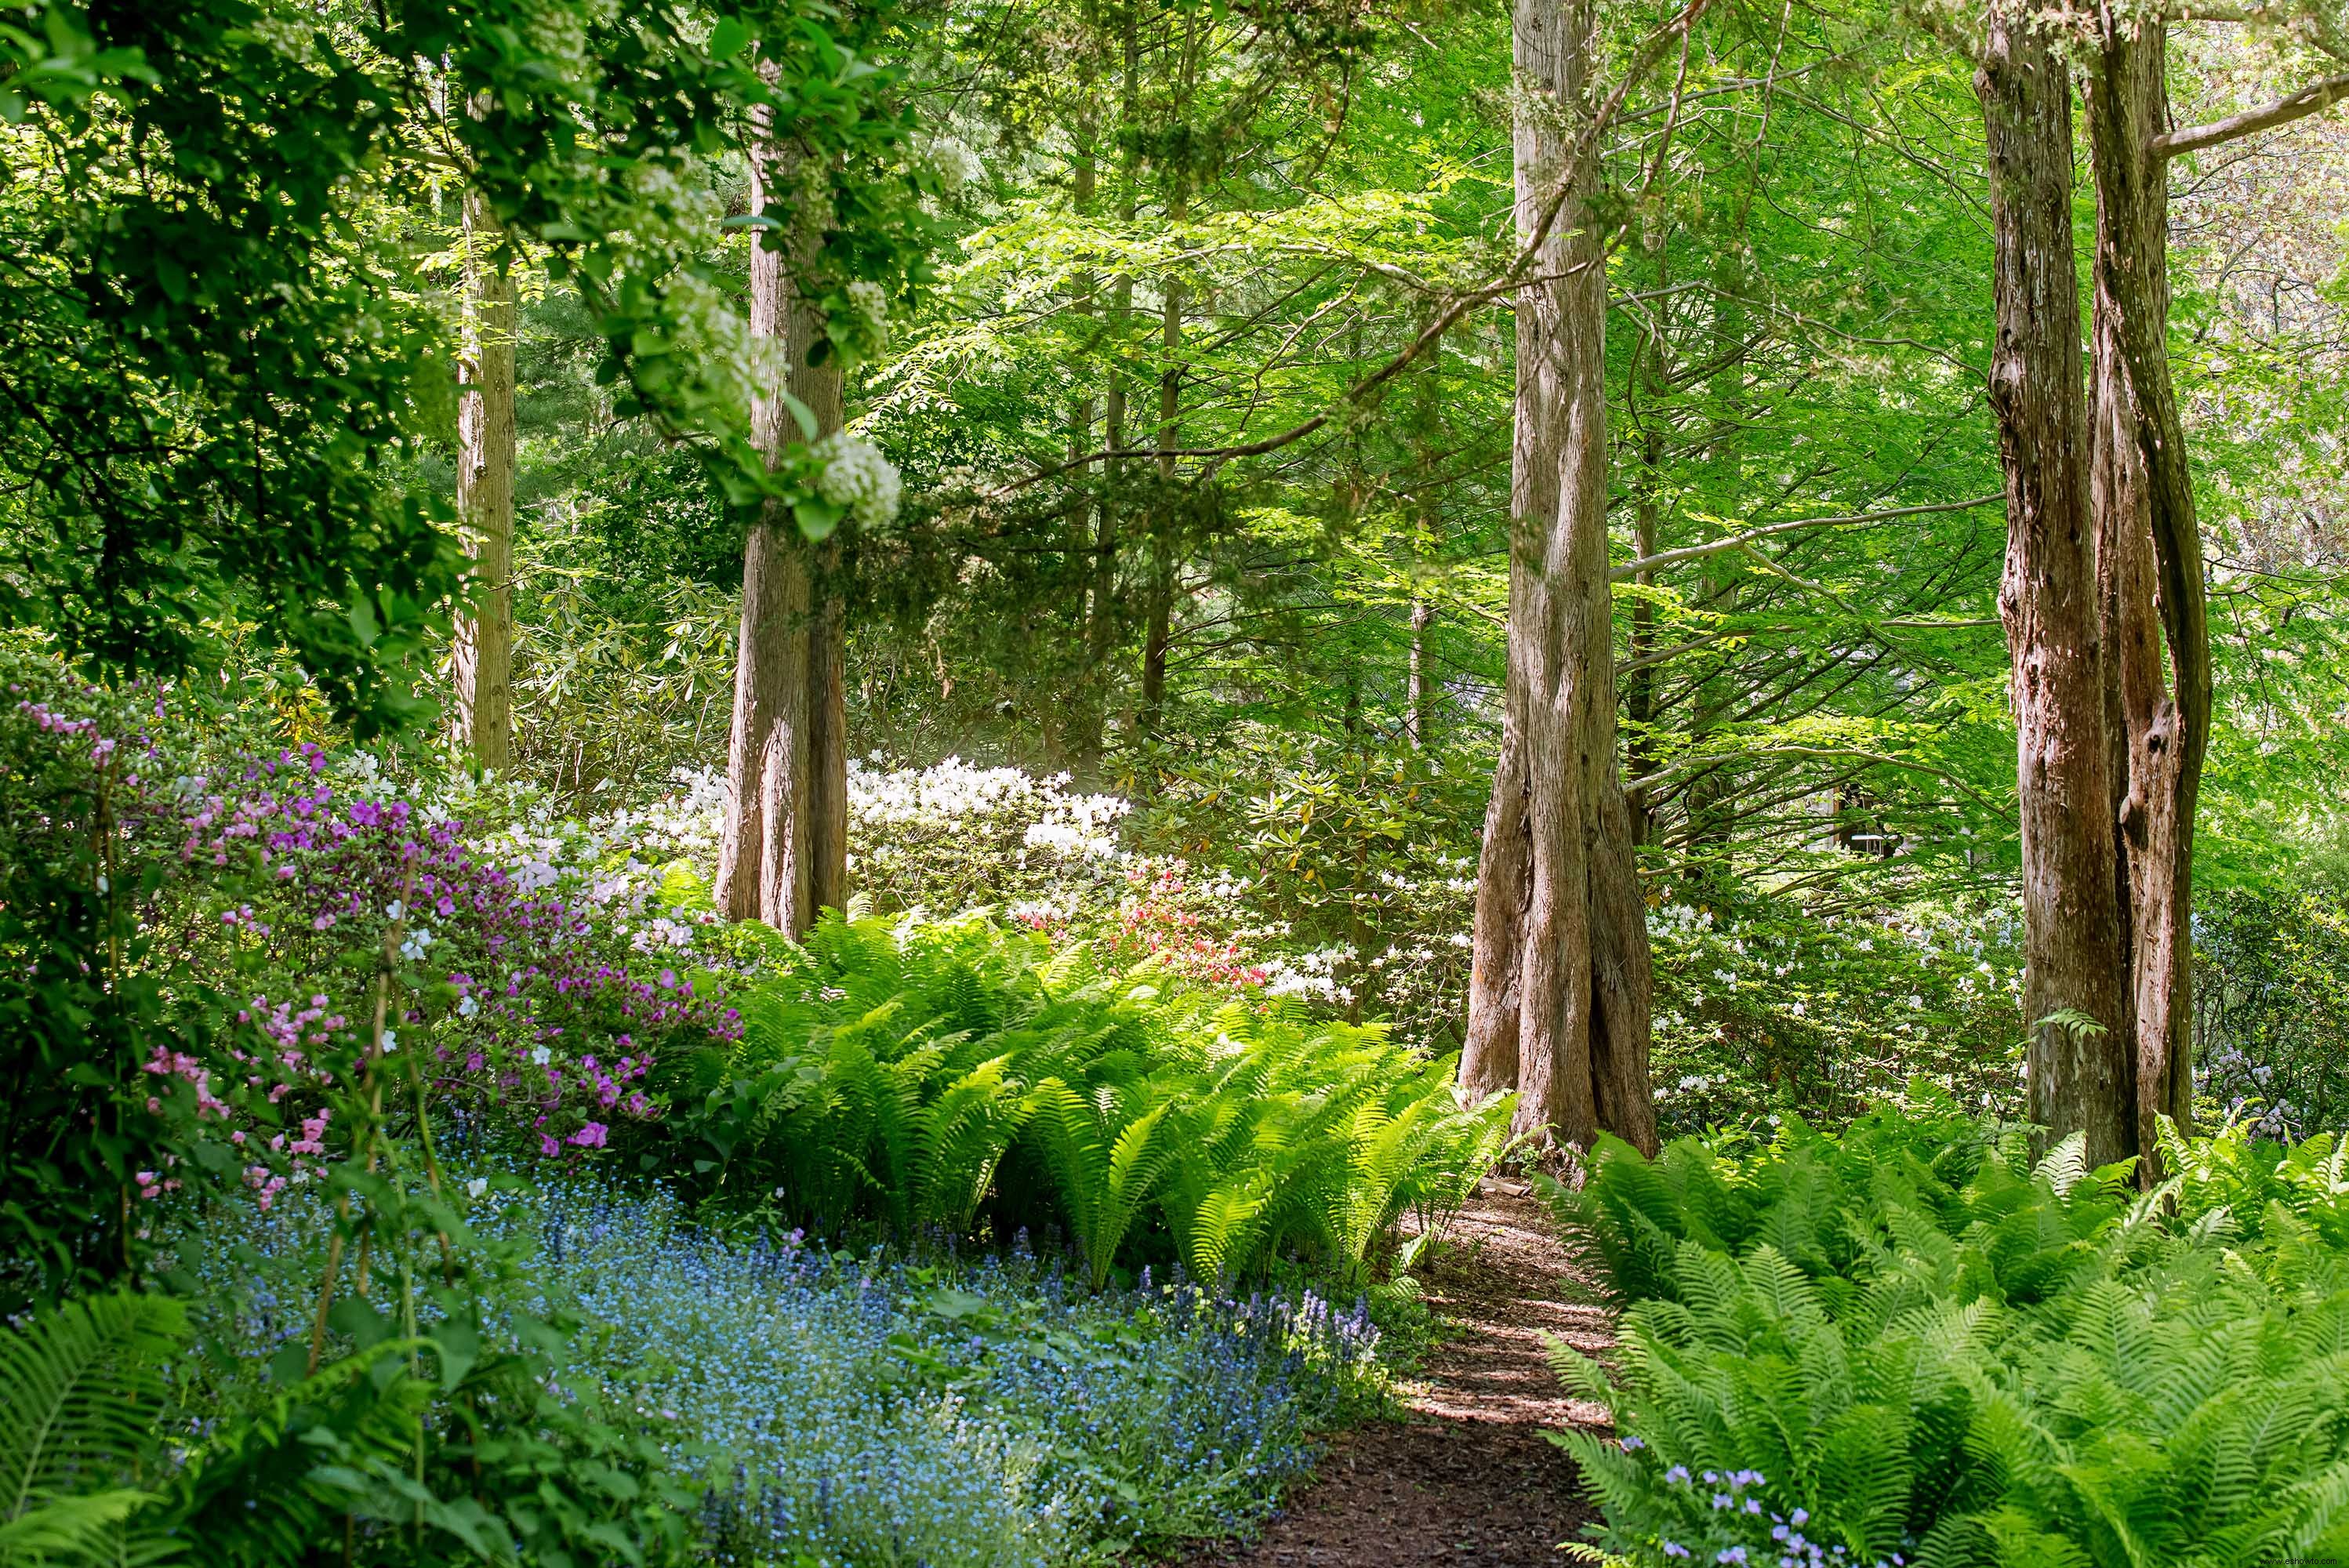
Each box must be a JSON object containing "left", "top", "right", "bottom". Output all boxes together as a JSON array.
[{"left": 1191, "top": 1178, "right": 1611, "bottom": 1568}]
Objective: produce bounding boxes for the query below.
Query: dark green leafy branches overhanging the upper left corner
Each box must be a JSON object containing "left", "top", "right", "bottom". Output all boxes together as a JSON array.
[{"left": 0, "top": 0, "right": 911, "bottom": 732}]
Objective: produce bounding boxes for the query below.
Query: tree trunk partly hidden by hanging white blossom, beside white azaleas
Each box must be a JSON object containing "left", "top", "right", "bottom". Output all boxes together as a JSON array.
[{"left": 717, "top": 131, "right": 848, "bottom": 937}]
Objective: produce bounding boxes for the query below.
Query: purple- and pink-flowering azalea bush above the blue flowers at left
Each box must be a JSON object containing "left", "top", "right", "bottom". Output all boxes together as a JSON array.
[{"left": 7, "top": 666, "right": 740, "bottom": 1267}]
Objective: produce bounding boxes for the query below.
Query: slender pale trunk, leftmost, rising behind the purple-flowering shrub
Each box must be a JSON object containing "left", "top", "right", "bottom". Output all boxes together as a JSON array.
[{"left": 456, "top": 191, "right": 519, "bottom": 770}]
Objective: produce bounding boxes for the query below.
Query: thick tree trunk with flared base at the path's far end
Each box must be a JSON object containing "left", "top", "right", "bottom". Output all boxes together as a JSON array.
[{"left": 1461, "top": 0, "right": 1656, "bottom": 1150}]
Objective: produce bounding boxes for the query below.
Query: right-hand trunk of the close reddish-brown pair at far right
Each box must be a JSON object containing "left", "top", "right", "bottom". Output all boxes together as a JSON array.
[{"left": 2088, "top": 16, "right": 2210, "bottom": 1150}]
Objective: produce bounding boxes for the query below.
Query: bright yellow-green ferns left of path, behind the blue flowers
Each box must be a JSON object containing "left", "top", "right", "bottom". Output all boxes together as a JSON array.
[{"left": 679, "top": 916, "right": 1508, "bottom": 1287}]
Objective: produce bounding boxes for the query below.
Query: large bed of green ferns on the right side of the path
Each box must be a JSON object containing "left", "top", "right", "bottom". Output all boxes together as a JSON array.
[{"left": 1555, "top": 1096, "right": 2349, "bottom": 1568}]
